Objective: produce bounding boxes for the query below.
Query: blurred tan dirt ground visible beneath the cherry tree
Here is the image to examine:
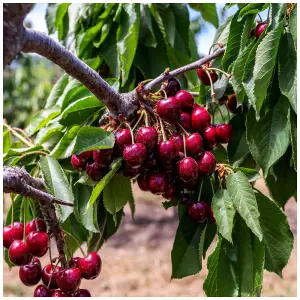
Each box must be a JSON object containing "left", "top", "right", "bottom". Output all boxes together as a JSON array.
[{"left": 4, "top": 179, "right": 297, "bottom": 297}]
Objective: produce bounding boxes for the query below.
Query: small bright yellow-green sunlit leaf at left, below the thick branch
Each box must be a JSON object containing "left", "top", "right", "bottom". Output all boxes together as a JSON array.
[{"left": 25, "top": 106, "right": 60, "bottom": 136}]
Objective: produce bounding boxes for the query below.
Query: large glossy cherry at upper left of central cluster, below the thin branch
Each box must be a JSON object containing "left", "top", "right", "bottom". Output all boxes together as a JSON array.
[{"left": 156, "top": 96, "right": 180, "bottom": 123}]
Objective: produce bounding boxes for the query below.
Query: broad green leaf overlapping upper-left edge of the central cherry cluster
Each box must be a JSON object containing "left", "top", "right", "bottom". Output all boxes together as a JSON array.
[{"left": 73, "top": 126, "right": 115, "bottom": 154}]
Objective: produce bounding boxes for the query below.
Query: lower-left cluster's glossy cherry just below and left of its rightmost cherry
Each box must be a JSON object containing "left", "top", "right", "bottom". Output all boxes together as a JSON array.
[{"left": 56, "top": 268, "right": 81, "bottom": 293}]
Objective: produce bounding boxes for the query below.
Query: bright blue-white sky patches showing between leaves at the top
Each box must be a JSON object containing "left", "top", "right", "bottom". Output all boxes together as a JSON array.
[{"left": 26, "top": 3, "right": 237, "bottom": 55}]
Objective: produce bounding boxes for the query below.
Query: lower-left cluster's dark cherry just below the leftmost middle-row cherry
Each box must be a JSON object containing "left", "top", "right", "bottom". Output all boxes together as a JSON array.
[{"left": 19, "top": 257, "right": 42, "bottom": 286}]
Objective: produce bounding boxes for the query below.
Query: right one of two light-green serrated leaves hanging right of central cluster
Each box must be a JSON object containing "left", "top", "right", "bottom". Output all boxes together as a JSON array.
[{"left": 226, "top": 171, "right": 263, "bottom": 240}]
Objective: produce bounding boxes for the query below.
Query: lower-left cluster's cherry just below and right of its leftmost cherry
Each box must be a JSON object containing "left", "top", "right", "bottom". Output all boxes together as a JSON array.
[{"left": 8, "top": 240, "right": 31, "bottom": 266}]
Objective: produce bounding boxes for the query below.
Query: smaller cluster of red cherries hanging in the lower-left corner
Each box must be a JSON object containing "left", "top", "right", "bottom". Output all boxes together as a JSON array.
[{"left": 3, "top": 218, "right": 102, "bottom": 297}]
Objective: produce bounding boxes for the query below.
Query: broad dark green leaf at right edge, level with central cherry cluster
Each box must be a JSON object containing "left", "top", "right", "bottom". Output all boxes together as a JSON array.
[{"left": 247, "top": 96, "right": 289, "bottom": 177}]
